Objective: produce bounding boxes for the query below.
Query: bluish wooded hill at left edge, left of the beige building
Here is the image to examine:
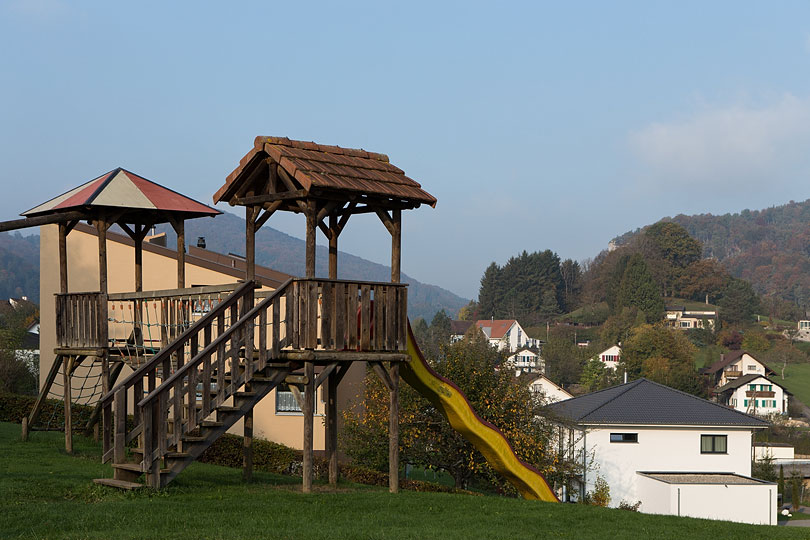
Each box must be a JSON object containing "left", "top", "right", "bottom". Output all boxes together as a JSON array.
[{"left": 0, "top": 233, "right": 39, "bottom": 304}]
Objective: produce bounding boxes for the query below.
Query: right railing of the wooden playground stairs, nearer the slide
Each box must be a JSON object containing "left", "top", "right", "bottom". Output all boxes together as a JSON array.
[{"left": 137, "top": 280, "right": 292, "bottom": 487}]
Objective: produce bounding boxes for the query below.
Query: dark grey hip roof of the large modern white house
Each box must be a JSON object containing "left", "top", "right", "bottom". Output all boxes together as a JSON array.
[{"left": 548, "top": 379, "right": 768, "bottom": 428}]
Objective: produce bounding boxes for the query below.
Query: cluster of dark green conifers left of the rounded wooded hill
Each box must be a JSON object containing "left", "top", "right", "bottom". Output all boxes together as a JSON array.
[{"left": 478, "top": 250, "right": 564, "bottom": 325}]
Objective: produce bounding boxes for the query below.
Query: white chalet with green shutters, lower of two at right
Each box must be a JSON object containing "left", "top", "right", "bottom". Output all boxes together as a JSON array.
[{"left": 714, "top": 373, "right": 791, "bottom": 415}]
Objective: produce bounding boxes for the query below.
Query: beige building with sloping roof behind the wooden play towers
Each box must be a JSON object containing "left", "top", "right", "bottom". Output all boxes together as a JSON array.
[{"left": 40, "top": 223, "right": 365, "bottom": 451}]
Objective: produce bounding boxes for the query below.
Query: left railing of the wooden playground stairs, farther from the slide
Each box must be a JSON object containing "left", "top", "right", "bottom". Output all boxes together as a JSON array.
[{"left": 101, "top": 282, "right": 256, "bottom": 463}]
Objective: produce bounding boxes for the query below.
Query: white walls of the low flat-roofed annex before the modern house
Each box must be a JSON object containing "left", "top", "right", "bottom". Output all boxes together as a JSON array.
[{"left": 637, "top": 475, "right": 778, "bottom": 525}]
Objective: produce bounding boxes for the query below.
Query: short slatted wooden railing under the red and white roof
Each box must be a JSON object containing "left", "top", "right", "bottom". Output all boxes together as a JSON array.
[{"left": 56, "top": 292, "right": 107, "bottom": 349}]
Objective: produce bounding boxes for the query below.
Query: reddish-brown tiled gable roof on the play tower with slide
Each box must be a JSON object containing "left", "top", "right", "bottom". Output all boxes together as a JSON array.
[{"left": 214, "top": 137, "right": 436, "bottom": 206}]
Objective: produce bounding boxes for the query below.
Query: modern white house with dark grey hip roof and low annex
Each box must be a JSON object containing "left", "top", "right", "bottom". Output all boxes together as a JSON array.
[{"left": 548, "top": 379, "right": 777, "bottom": 525}]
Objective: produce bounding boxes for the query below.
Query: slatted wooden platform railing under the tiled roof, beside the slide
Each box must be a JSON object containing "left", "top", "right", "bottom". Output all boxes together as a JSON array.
[{"left": 286, "top": 279, "right": 408, "bottom": 352}]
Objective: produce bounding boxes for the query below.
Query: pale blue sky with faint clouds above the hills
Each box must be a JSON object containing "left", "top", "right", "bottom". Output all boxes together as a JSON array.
[{"left": 0, "top": 0, "right": 810, "bottom": 297}]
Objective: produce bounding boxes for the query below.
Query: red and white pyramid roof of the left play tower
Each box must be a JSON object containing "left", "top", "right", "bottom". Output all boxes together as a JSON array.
[{"left": 21, "top": 167, "right": 222, "bottom": 222}]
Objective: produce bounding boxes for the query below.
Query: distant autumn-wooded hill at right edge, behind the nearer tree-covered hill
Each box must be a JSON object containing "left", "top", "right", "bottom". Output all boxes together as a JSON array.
[{"left": 614, "top": 200, "right": 810, "bottom": 310}]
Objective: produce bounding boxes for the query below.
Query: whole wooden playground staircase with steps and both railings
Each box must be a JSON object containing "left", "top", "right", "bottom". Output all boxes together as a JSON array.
[{"left": 94, "top": 281, "right": 299, "bottom": 489}]
